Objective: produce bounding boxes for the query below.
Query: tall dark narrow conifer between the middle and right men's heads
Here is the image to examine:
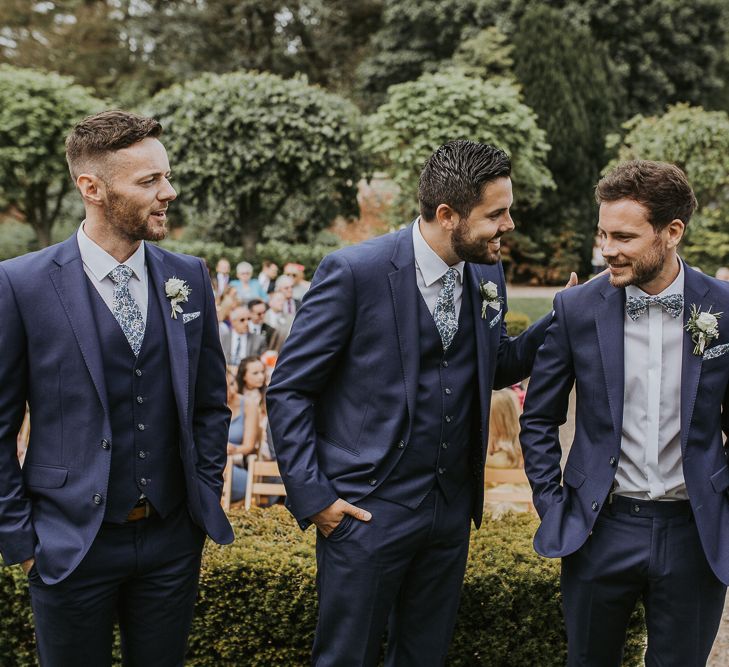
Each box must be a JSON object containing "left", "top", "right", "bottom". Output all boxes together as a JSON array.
[{"left": 514, "top": 5, "right": 620, "bottom": 282}]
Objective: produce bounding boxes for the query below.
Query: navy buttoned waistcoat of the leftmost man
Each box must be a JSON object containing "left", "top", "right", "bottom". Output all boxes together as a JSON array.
[{"left": 88, "top": 281, "right": 185, "bottom": 523}]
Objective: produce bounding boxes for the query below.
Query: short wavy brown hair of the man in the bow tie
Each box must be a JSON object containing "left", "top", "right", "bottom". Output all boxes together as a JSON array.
[{"left": 595, "top": 160, "right": 698, "bottom": 232}]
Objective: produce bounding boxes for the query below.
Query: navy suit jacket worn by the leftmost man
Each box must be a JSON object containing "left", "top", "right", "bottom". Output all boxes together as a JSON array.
[{"left": 0, "top": 234, "right": 233, "bottom": 584}]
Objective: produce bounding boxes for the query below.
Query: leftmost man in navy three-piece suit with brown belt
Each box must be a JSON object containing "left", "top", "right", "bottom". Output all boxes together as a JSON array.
[{"left": 0, "top": 111, "right": 233, "bottom": 667}]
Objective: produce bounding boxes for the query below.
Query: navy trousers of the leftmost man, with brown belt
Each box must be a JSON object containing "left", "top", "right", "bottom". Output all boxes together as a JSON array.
[{"left": 28, "top": 503, "right": 205, "bottom": 667}]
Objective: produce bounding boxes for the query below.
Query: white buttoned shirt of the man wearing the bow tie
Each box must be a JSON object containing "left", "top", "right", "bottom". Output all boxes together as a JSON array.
[{"left": 613, "top": 259, "right": 688, "bottom": 500}]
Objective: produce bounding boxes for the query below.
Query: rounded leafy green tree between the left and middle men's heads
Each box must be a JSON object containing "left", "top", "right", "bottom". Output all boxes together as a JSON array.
[{"left": 150, "top": 72, "right": 365, "bottom": 255}]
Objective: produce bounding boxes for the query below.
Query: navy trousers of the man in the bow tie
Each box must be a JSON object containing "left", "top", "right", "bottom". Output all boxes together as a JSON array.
[{"left": 562, "top": 496, "right": 726, "bottom": 667}]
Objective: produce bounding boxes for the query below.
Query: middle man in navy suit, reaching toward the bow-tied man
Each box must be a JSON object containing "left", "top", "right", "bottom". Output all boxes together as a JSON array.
[{"left": 268, "top": 141, "right": 576, "bottom": 667}]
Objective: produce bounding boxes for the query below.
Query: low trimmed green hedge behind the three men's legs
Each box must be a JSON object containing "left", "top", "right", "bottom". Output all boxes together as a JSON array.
[{"left": 0, "top": 506, "right": 644, "bottom": 667}]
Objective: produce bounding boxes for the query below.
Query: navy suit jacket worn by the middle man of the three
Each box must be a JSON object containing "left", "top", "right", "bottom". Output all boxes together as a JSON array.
[{"left": 267, "top": 226, "right": 547, "bottom": 528}]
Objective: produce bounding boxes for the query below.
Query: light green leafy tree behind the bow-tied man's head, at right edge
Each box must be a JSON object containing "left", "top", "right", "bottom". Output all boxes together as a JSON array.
[{"left": 606, "top": 104, "right": 729, "bottom": 274}]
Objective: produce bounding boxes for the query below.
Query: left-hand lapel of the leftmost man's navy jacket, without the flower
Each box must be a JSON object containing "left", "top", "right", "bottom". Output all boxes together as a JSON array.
[{"left": 50, "top": 234, "right": 109, "bottom": 416}]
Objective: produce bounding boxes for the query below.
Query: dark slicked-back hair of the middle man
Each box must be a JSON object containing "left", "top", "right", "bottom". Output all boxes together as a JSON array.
[{"left": 418, "top": 139, "right": 511, "bottom": 222}]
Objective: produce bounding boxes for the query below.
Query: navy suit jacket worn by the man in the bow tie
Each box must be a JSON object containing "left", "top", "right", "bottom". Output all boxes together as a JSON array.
[{"left": 521, "top": 264, "right": 729, "bottom": 584}]
